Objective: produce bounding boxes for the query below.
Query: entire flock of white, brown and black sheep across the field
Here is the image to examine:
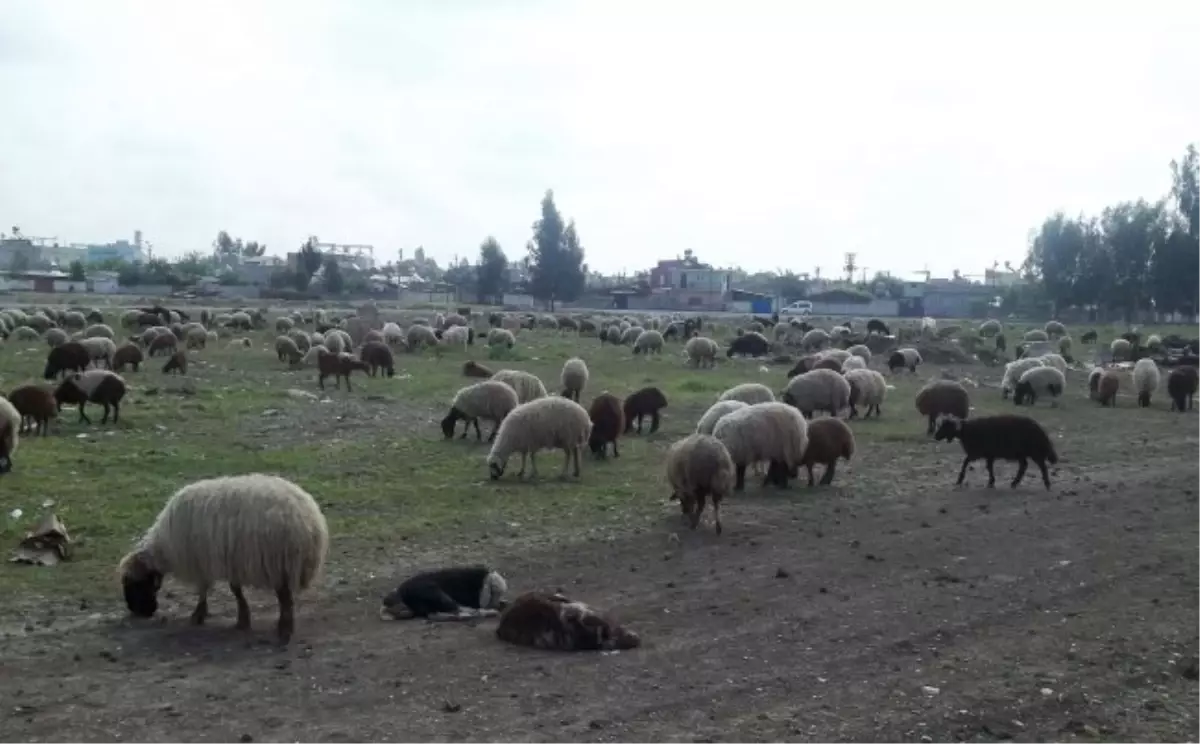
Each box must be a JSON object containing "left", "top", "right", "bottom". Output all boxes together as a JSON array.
[{"left": 0, "top": 306, "right": 1198, "bottom": 649}]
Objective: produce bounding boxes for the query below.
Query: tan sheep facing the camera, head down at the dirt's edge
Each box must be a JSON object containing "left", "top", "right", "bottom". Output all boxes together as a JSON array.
[{"left": 666, "top": 434, "right": 736, "bottom": 534}]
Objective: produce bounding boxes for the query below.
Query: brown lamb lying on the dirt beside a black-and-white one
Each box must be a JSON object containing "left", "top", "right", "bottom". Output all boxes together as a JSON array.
[{"left": 496, "top": 592, "right": 642, "bottom": 650}]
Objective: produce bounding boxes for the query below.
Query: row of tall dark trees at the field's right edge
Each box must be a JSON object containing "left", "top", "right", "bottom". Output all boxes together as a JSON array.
[{"left": 1024, "top": 145, "right": 1200, "bottom": 322}]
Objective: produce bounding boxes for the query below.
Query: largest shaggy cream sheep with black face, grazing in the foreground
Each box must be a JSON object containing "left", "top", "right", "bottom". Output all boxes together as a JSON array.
[{"left": 120, "top": 473, "right": 329, "bottom": 643}]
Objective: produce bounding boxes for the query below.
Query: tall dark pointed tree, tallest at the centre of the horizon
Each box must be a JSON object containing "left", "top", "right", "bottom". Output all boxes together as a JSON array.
[{"left": 528, "top": 191, "right": 588, "bottom": 312}]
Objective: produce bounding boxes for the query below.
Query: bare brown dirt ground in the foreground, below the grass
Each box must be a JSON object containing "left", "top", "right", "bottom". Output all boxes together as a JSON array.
[{"left": 0, "top": 414, "right": 1200, "bottom": 744}]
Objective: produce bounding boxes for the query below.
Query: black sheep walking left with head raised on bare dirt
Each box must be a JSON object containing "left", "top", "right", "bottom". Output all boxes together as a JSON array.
[{"left": 934, "top": 415, "right": 1058, "bottom": 491}]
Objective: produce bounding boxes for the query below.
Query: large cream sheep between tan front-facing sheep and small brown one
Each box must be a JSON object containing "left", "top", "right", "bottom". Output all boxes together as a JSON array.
[{"left": 713, "top": 403, "right": 808, "bottom": 491}]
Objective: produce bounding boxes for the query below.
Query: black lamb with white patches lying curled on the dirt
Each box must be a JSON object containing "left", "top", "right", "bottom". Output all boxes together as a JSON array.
[{"left": 379, "top": 565, "right": 509, "bottom": 620}]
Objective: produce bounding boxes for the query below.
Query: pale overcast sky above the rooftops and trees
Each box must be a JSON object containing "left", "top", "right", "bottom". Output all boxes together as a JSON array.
[{"left": 0, "top": 0, "right": 1200, "bottom": 276}]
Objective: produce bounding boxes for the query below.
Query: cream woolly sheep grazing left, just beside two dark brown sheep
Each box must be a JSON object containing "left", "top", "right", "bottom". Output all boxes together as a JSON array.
[{"left": 487, "top": 397, "right": 592, "bottom": 480}]
